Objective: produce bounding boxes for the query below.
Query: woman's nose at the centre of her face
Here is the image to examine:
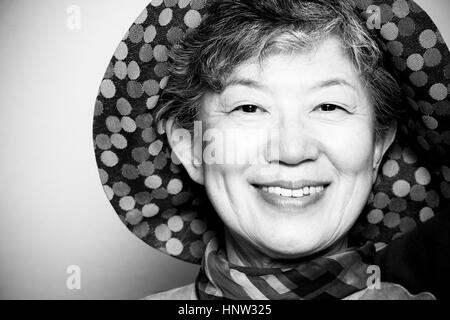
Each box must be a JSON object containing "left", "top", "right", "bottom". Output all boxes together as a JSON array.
[{"left": 267, "top": 117, "right": 320, "bottom": 166}]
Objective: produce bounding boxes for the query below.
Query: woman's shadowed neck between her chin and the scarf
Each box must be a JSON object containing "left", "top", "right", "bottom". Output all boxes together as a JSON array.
[{"left": 225, "top": 230, "right": 347, "bottom": 268}]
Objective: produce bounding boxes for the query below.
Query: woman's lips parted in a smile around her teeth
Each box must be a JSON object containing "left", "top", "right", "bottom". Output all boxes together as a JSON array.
[{"left": 252, "top": 183, "right": 329, "bottom": 213}]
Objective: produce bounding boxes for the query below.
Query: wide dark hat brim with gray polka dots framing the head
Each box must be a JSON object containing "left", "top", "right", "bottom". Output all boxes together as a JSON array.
[{"left": 93, "top": 0, "right": 450, "bottom": 263}]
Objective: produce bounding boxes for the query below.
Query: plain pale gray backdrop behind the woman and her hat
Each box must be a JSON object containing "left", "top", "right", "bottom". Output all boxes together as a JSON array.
[{"left": 0, "top": 0, "right": 450, "bottom": 299}]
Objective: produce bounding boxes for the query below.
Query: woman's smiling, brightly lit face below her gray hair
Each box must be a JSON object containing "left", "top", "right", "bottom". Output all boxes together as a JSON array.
[{"left": 169, "top": 38, "right": 394, "bottom": 258}]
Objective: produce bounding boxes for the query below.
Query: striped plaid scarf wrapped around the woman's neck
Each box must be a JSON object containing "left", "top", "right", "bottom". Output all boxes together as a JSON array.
[{"left": 195, "top": 239, "right": 375, "bottom": 300}]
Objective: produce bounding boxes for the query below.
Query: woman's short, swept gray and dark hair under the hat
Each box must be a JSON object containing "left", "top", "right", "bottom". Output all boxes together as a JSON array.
[{"left": 154, "top": 0, "right": 402, "bottom": 134}]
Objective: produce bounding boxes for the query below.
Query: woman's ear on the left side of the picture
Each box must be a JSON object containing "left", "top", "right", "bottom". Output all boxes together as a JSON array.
[{"left": 164, "top": 118, "right": 204, "bottom": 185}]
